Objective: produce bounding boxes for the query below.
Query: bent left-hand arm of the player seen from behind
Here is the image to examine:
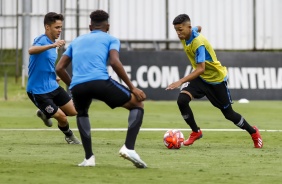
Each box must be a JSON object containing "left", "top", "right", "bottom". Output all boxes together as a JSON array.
[{"left": 56, "top": 55, "right": 71, "bottom": 86}]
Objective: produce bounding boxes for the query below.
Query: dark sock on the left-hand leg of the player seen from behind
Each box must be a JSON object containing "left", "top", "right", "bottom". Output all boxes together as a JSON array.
[{"left": 76, "top": 117, "right": 94, "bottom": 159}]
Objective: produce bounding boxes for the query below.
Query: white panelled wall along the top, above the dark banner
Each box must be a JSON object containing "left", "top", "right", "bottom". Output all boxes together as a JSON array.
[{"left": 0, "top": 0, "right": 282, "bottom": 50}]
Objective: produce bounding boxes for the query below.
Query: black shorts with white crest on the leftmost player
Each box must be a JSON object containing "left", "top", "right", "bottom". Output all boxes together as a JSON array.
[{"left": 27, "top": 86, "right": 71, "bottom": 118}]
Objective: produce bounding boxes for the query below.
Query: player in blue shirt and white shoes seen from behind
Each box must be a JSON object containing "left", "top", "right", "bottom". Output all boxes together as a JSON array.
[{"left": 56, "top": 10, "right": 147, "bottom": 168}]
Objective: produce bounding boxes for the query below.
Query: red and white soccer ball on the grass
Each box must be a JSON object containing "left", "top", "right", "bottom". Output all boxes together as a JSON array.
[{"left": 164, "top": 129, "right": 184, "bottom": 149}]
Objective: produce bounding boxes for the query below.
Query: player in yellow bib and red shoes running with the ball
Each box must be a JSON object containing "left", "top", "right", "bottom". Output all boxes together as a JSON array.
[{"left": 166, "top": 14, "right": 263, "bottom": 148}]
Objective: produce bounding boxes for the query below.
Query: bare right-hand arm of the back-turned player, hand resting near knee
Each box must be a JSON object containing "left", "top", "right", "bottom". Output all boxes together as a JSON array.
[{"left": 109, "top": 49, "right": 146, "bottom": 101}]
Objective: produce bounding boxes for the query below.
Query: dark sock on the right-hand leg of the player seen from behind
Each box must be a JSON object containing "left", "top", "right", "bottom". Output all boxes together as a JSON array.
[{"left": 125, "top": 108, "right": 144, "bottom": 150}]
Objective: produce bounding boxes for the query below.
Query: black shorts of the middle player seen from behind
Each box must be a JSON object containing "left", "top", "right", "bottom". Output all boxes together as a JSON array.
[{"left": 71, "top": 78, "right": 131, "bottom": 115}]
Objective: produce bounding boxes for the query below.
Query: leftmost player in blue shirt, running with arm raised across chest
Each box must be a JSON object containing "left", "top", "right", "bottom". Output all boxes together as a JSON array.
[{"left": 26, "top": 12, "right": 81, "bottom": 144}]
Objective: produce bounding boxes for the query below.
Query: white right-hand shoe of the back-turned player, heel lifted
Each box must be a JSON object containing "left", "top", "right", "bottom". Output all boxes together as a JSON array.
[{"left": 119, "top": 145, "right": 147, "bottom": 168}]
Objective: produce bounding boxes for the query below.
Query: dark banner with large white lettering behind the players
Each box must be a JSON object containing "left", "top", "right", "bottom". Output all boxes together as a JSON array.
[{"left": 109, "top": 51, "right": 282, "bottom": 100}]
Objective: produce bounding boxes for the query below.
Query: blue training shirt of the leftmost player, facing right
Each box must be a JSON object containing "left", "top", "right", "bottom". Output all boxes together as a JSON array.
[{"left": 26, "top": 34, "right": 59, "bottom": 94}]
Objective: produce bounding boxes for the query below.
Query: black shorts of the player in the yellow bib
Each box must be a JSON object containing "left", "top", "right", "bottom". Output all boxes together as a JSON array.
[{"left": 181, "top": 77, "right": 232, "bottom": 109}]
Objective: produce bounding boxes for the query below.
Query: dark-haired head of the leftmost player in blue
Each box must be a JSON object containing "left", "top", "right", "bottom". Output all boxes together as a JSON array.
[{"left": 44, "top": 12, "right": 64, "bottom": 41}]
